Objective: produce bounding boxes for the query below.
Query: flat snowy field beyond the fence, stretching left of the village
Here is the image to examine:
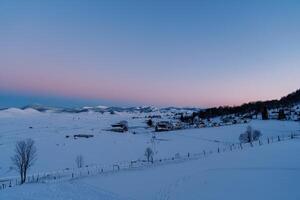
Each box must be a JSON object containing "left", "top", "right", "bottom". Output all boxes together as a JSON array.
[{"left": 0, "top": 109, "right": 300, "bottom": 177}]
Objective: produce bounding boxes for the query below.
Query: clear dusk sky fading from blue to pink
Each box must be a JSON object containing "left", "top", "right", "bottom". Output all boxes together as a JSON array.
[{"left": 0, "top": 0, "right": 300, "bottom": 107}]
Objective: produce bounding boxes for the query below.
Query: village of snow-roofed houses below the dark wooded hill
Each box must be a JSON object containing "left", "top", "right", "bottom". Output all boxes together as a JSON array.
[{"left": 102, "top": 106, "right": 300, "bottom": 134}]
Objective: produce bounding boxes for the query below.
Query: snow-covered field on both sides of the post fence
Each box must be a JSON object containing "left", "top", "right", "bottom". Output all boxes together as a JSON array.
[{"left": 0, "top": 109, "right": 300, "bottom": 200}]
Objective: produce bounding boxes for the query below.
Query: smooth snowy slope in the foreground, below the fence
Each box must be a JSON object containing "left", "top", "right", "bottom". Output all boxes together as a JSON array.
[{"left": 0, "top": 140, "right": 300, "bottom": 200}]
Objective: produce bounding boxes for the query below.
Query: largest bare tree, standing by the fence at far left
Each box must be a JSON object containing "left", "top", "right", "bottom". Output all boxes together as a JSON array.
[{"left": 11, "top": 139, "right": 37, "bottom": 184}]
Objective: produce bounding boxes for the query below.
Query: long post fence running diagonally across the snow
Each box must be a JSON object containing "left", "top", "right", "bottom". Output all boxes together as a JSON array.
[{"left": 0, "top": 133, "right": 300, "bottom": 190}]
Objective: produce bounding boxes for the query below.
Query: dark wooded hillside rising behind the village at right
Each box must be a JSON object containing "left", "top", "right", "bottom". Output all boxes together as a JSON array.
[{"left": 190, "top": 89, "right": 300, "bottom": 120}]
